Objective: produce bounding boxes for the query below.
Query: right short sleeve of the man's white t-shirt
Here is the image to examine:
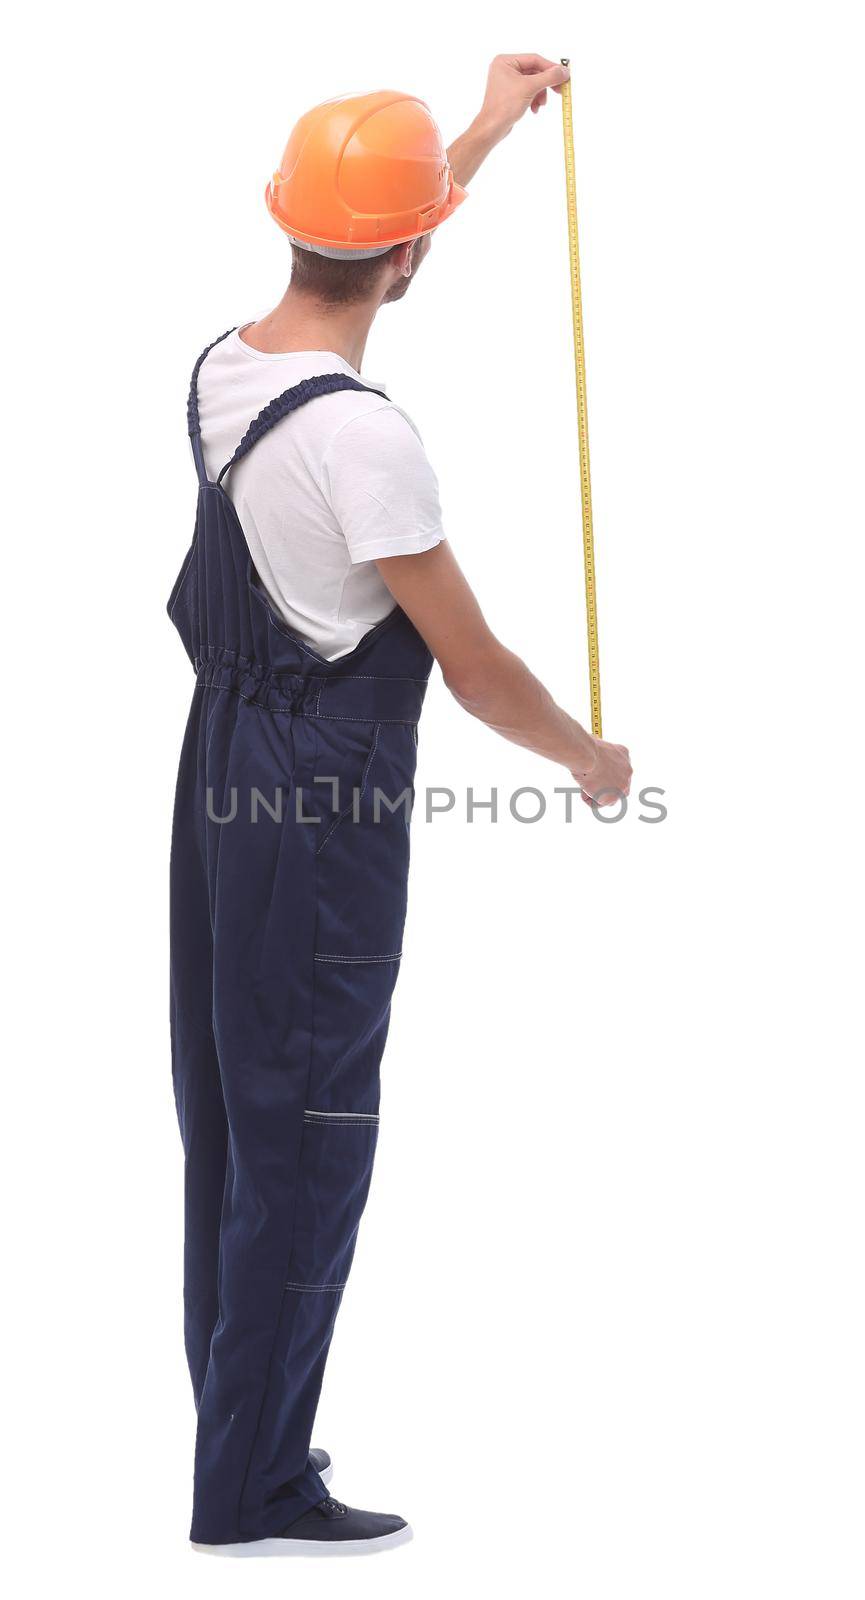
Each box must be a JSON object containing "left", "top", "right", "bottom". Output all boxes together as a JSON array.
[{"left": 321, "top": 405, "right": 444, "bottom": 562}]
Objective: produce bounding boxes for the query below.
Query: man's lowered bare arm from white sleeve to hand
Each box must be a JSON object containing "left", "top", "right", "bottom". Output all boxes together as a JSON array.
[{"left": 376, "top": 542, "right": 632, "bottom": 805}]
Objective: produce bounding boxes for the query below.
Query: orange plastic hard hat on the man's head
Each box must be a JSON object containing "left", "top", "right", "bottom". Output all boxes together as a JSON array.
[{"left": 265, "top": 90, "right": 465, "bottom": 258}]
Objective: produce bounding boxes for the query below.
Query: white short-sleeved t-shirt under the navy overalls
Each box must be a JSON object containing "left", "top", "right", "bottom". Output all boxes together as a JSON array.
[{"left": 198, "top": 331, "right": 444, "bottom": 661}]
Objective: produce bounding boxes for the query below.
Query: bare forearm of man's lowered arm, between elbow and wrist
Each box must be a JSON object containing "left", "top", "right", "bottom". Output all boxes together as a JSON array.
[{"left": 444, "top": 640, "right": 596, "bottom": 773}]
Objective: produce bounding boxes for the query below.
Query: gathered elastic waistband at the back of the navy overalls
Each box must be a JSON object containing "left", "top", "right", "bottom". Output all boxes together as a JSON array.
[{"left": 195, "top": 646, "right": 427, "bottom": 723}]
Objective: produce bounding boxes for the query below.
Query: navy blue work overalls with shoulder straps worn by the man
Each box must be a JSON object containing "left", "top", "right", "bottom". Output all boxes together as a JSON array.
[{"left": 168, "top": 334, "right": 432, "bottom": 1544}]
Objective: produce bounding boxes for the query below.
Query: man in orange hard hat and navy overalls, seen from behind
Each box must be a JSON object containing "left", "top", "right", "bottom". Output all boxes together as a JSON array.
[{"left": 169, "top": 56, "right": 630, "bottom": 1555}]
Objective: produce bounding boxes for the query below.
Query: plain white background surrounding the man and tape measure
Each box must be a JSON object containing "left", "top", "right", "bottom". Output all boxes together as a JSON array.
[{"left": 2, "top": 0, "right": 865, "bottom": 1600}]
